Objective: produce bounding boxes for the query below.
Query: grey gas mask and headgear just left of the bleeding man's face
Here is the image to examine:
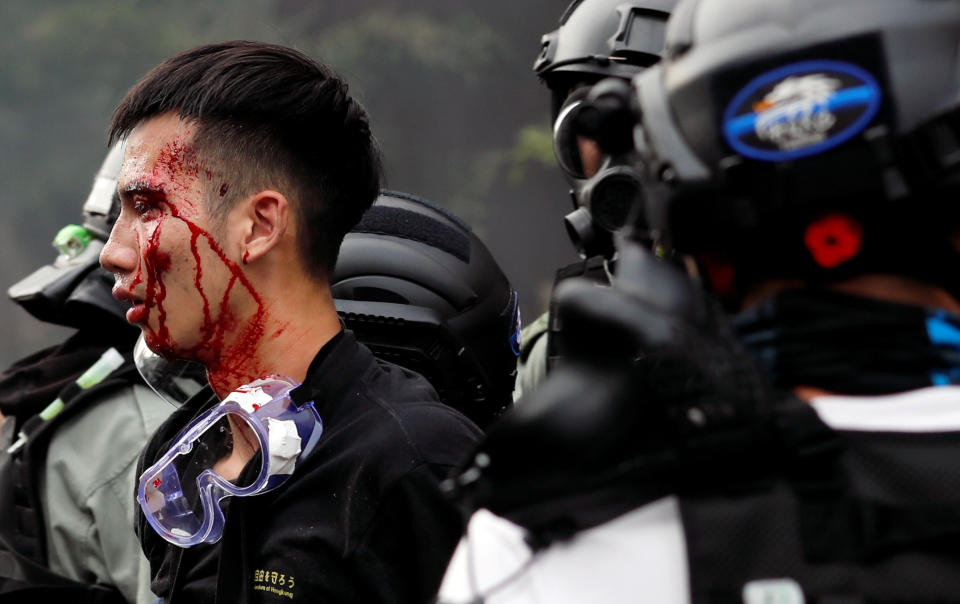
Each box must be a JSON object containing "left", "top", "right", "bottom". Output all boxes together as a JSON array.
[{"left": 7, "top": 141, "right": 132, "bottom": 329}]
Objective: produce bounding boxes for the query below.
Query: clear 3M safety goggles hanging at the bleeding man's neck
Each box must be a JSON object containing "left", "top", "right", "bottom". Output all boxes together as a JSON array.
[{"left": 137, "top": 375, "right": 323, "bottom": 547}]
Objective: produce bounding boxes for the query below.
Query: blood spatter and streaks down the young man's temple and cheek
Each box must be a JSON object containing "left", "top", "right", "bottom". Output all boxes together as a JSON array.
[{"left": 116, "top": 119, "right": 285, "bottom": 393}]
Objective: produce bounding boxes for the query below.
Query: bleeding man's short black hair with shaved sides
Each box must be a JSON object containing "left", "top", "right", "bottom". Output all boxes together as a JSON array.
[{"left": 109, "top": 41, "right": 381, "bottom": 277}]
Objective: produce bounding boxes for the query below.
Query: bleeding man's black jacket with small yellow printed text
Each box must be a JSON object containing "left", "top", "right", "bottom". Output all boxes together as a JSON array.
[{"left": 138, "top": 332, "right": 481, "bottom": 604}]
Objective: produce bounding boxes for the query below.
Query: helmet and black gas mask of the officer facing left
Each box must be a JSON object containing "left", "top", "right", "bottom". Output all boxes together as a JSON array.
[{"left": 533, "top": 0, "right": 676, "bottom": 257}]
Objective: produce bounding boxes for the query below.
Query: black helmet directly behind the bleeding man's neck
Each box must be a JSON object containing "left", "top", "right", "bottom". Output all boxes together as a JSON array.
[{"left": 330, "top": 191, "right": 520, "bottom": 427}]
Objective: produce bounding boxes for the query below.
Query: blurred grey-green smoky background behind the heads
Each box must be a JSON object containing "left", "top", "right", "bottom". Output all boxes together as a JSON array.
[{"left": 0, "top": 0, "right": 575, "bottom": 366}]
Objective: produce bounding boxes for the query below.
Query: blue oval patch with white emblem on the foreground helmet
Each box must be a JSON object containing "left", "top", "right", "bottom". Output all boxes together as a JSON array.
[{"left": 723, "top": 61, "right": 882, "bottom": 161}]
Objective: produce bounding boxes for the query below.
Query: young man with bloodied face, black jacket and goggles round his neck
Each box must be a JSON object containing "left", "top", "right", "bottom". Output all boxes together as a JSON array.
[{"left": 101, "top": 42, "right": 479, "bottom": 602}]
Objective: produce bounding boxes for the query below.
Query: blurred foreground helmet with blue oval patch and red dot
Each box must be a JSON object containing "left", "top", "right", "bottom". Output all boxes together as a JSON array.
[{"left": 634, "top": 0, "right": 960, "bottom": 302}]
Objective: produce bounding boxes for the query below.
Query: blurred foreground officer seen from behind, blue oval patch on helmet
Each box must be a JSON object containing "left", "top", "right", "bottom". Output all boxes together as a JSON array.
[{"left": 441, "top": 0, "right": 960, "bottom": 604}]
